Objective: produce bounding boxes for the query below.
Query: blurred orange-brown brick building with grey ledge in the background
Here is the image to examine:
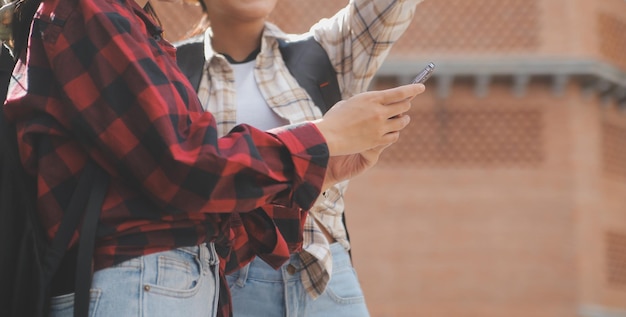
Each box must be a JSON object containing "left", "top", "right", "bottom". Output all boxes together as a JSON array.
[{"left": 152, "top": 0, "right": 626, "bottom": 317}]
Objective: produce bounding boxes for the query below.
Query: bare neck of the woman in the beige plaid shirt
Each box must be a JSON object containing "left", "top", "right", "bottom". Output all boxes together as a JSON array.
[{"left": 206, "top": 18, "right": 264, "bottom": 61}]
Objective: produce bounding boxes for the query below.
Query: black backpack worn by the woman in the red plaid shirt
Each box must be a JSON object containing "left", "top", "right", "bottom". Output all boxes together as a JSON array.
[{"left": 0, "top": 40, "right": 108, "bottom": 317}]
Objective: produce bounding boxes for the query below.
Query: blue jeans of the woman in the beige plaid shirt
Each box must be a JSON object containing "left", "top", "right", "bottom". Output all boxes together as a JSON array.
[{"left": 226, "top": 243, "right": 369, "bottom": 317}]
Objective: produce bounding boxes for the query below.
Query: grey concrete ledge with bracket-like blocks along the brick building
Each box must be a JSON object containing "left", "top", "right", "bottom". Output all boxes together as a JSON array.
[{"left": 377, "top": 58, "right": 626, "bottom": 103}]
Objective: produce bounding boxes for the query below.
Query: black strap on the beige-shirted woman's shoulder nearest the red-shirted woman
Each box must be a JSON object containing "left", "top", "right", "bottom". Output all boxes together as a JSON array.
[{"left": 175, "top": 35, "right": 205, "bottom": 91}]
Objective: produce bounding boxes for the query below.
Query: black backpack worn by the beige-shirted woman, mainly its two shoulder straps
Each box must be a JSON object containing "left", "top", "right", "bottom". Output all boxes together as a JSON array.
[{"left": 175, "top": 34, "right": 352, "bottom": 255}]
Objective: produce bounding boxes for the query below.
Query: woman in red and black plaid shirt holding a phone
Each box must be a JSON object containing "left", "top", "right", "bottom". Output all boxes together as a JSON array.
[{"left": 4, "top": 0, "right": 424, "bottom": 316}]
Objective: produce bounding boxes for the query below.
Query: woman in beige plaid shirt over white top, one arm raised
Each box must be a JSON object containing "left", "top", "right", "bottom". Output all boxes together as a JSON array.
[{"left": 179, "top": 0, "right": 422, "bottom": 317}]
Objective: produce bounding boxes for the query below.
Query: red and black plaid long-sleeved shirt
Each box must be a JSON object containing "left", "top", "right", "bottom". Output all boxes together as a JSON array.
[{"left": 5, "top": 0, "right": 328, "bottom": 314}]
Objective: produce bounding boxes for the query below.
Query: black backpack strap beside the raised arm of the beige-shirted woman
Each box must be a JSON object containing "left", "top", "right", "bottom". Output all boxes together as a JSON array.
[{"left": 278, "top": 36, "right": 341, "bottom": 113}]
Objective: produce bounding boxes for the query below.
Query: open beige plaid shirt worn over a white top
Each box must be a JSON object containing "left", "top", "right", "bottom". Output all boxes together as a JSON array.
[{"left": 198, "top": 0, "right": 422, "bottom": 298}]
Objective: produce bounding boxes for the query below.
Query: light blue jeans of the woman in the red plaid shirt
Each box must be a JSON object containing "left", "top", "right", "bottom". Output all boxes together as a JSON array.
[{"left": 50, "top": 244, "right": 219, "bottom": 317}]
